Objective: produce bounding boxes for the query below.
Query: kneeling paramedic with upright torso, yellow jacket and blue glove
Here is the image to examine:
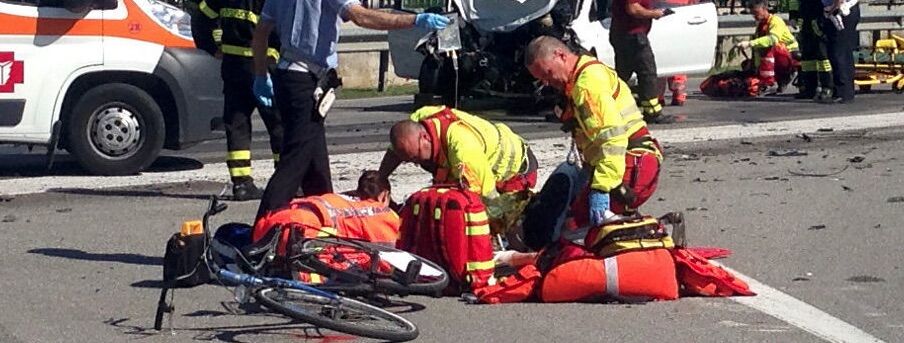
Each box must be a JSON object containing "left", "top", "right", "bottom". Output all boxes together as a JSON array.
[{"left": 525, "top": 36, "right": 662, "bottom": 226}]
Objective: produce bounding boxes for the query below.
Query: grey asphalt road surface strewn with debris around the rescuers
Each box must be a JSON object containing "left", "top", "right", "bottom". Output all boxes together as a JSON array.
[{"left": 0, "top": 88, "right": 904, "bottom": 342}]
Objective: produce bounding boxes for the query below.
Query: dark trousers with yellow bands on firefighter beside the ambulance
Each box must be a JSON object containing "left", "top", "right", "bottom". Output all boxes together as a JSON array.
[{"left": 220, "top": 55, "right": 283, "bottom": 184}]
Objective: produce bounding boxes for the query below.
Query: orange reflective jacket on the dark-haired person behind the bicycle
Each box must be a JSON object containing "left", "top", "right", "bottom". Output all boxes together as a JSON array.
[{"left": 252, "top": 194, "right": 400, "bottom": 255}]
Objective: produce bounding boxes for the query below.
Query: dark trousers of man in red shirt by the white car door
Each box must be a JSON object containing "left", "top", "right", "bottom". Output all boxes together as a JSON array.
[{"left": 609, "top": 31, "right": 662, "bottom": 117}]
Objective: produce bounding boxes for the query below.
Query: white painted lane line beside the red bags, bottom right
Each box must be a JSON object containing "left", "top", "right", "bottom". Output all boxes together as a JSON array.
[{"left": 713, "top": 261, "right": 883, "bottom": 343}]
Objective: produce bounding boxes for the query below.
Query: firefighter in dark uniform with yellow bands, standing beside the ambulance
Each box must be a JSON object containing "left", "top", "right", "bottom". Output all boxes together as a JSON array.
[{"left": 192, "top": 0, "right": 283, "bottom": 201}]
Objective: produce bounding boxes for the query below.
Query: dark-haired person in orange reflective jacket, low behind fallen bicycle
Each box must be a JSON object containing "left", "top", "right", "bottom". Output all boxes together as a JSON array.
[{"left": 252, "top": 170, "right": 400, "bottom": 283}]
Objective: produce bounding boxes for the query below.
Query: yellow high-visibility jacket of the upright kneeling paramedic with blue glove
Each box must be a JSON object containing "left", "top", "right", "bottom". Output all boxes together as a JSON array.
[{"left": 563, "top": 56, "right": 647, "bottom": 192}]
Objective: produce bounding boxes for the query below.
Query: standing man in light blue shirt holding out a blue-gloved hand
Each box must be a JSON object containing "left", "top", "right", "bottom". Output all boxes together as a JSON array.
[{"left": 252, "top": 0, "right": 449, "bottom": 218}]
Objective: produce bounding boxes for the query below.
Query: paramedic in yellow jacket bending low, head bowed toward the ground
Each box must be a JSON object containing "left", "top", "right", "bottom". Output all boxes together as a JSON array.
[{"left": 380, "top": 106, "right": 537, "bottom": 198}]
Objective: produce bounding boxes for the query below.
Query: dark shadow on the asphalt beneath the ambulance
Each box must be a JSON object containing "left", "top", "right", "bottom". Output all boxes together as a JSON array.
[{"left": 0, "top": 153, "right": 204, "bottom": 177}]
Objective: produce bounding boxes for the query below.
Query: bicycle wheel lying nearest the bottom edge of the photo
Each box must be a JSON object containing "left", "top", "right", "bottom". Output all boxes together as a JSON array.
[{"left": 255, "top": 287, "right": 418, "bottom": 342}]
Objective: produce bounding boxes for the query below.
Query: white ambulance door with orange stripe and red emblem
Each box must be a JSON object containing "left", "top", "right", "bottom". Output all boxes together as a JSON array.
[{"left": 0, "top": 0, "right": 104, "bottom": 144}]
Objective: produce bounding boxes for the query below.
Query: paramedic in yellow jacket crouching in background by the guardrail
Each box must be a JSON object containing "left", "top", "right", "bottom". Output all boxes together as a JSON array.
[{"left": 738, "top": 0, "right": 800, "bottom": 92}]
